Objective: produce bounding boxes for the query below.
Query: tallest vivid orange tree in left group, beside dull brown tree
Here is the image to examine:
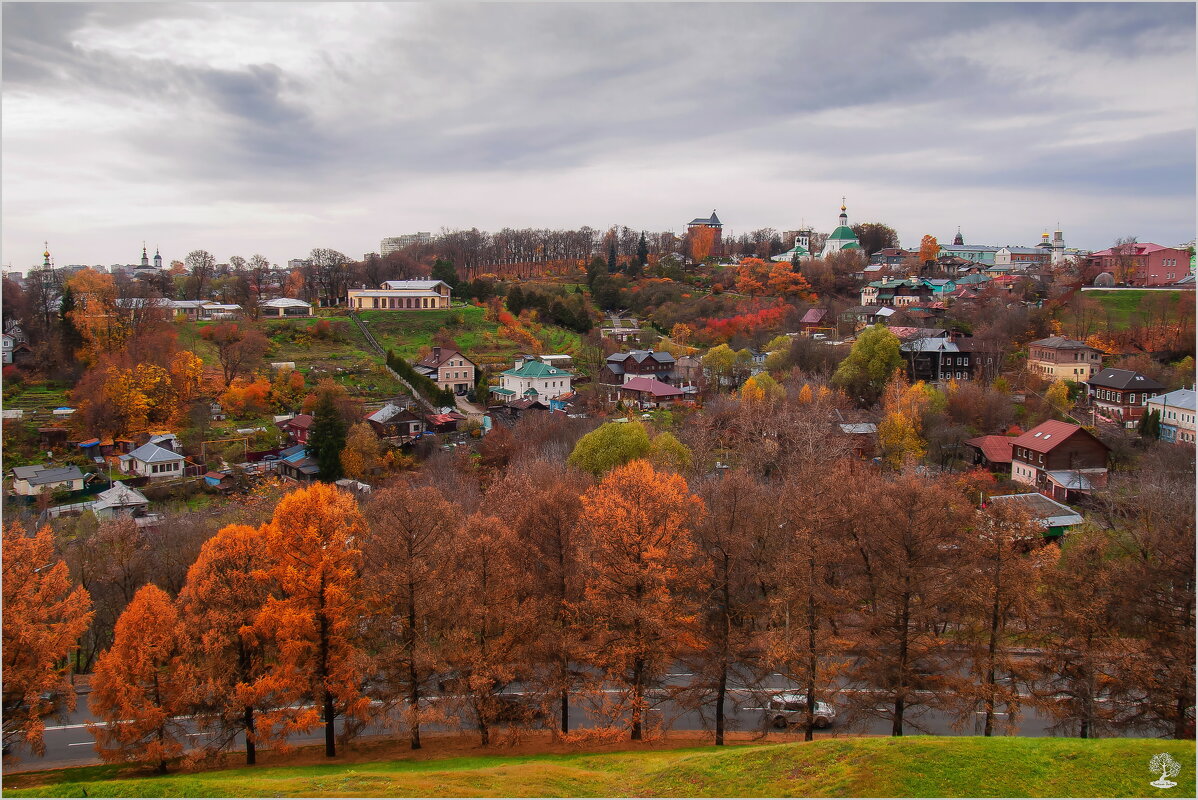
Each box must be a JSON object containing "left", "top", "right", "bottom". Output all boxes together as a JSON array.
[{"left": 255, "top": 484, "right": 370, "bottom": 758}]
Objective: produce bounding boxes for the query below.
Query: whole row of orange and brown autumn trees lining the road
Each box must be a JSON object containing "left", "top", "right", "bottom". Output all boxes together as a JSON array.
[{"left": 5, "top": 436, "right": 1194, "bottom": 766}]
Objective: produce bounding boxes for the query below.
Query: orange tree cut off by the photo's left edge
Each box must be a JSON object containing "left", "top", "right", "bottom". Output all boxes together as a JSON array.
[{"left": 4, "top": 522, "right": 93, "bottom": 756}]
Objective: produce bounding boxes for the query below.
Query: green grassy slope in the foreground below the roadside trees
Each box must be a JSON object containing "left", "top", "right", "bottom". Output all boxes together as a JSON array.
[{"left": 5, "top": 737, "right": 1194, "bottom": 798}]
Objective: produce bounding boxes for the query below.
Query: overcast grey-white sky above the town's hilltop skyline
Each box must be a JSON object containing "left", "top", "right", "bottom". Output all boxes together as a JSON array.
[{"left": 2, "top": 2, "right": 1196, "bottom": 269}]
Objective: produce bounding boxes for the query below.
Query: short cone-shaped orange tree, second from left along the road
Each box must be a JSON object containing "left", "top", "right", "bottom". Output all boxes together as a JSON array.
[{"left": 87, "top": 583, "right": 192, "bottom": 772}]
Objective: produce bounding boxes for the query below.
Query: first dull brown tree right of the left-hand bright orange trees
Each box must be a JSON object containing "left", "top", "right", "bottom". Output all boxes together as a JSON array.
[{"left": 362, "top": 484, "right": 458, "bottom": 750}]
